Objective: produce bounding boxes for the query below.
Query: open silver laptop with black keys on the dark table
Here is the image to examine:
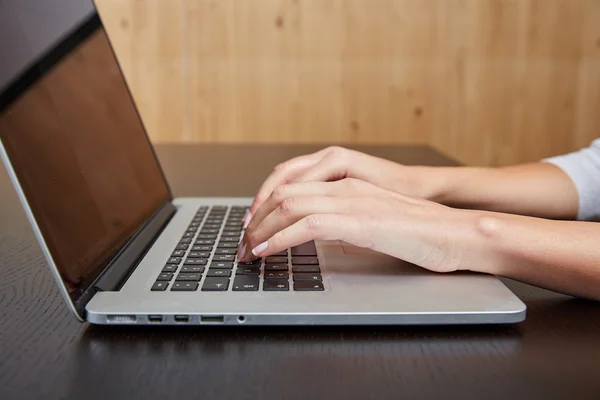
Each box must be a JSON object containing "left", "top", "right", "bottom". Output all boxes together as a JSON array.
[{"left": 0, "top": 0, "right": 525, "bottom": 326}]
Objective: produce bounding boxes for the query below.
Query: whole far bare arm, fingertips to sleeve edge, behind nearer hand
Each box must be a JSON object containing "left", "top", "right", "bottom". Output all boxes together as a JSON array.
[{"left": 245, "top": 147, "right": 579, "bottom": 225}]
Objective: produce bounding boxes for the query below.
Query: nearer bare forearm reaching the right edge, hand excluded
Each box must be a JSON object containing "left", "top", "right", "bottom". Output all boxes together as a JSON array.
[{"left": 463, "top": 211, "right": 600, "bottom": 300}]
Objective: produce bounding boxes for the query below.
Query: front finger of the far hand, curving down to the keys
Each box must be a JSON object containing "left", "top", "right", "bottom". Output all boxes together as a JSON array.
[{"left": 250, "top": 149, "right": 328, "bottom": 225}]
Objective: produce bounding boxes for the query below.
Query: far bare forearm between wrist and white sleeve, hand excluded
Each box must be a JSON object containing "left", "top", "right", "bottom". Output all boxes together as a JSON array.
[{"left": 409, "top": 163, "right": 579, "bottom": 219}]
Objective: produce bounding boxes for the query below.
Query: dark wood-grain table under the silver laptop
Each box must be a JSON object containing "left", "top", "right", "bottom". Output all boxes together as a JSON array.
[{"left": 0, "top": 145, "right": 600, "bottom": 400}]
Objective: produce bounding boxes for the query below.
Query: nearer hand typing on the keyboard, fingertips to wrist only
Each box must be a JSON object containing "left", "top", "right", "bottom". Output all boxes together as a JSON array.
[{"left": 239, "top": 179, "right": 486, "bottom": 272}]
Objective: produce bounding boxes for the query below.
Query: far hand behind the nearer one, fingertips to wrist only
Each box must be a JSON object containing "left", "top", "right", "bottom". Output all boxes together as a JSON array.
[{"left": 245, "top": 147, "right": 440, "bottom": 226}]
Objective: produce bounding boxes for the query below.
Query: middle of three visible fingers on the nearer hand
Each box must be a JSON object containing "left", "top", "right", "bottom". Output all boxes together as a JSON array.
[{"left": 244, "top": 196, "right": 356, "bottom": 258}]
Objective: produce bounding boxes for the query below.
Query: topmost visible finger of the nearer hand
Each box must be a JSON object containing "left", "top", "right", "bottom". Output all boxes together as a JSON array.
[{"left": 246, "top": 181, "right": 361, "bottom": 236}]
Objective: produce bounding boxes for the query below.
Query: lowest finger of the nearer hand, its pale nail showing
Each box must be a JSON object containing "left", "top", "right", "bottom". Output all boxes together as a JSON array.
[{"left": 251, "top": 214, "right": 367, "bottom": 257}]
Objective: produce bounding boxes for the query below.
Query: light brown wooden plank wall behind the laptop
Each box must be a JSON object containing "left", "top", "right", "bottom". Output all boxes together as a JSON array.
[{"left": 97, "top": 0, "right": 600, "bottom": 165}]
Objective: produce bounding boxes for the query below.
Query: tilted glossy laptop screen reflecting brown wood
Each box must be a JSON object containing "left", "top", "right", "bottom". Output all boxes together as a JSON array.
[{"left": 0, "top": 0, "right": 170, "bottom": 301}]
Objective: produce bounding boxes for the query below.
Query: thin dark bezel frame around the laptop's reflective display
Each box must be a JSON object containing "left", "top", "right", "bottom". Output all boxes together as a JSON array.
[{"left": 0, "top": 4, "right": 175, "bottom": 321}]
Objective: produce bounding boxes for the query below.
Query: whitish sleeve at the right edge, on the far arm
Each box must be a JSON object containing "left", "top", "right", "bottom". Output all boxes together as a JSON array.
[{"left": 543, "top": 139, "right": 600, "bottom": 221}]
